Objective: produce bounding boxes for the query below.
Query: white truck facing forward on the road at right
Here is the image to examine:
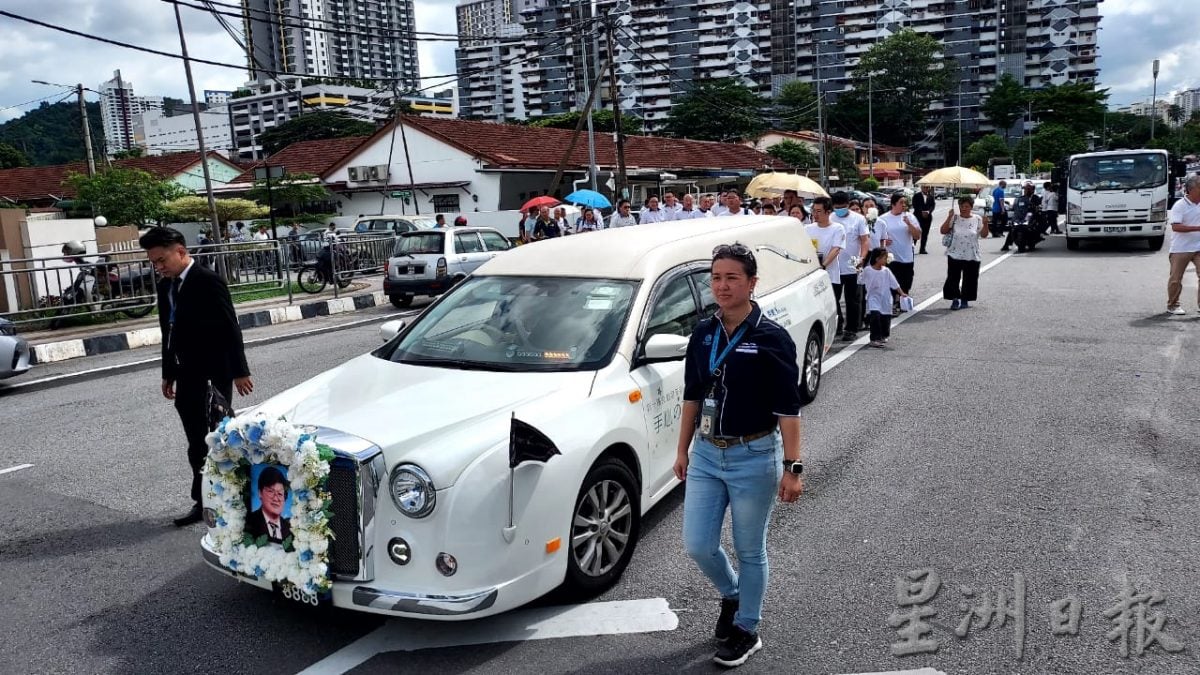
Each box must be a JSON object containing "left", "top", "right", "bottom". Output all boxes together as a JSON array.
[{"left": 1062, "top": 149, "right": 1175, "bottom": 251}]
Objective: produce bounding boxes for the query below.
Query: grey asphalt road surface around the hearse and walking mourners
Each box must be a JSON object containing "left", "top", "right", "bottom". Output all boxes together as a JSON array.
[{"left": 0, "top": 211, "right": 1200, "bottom": 674}]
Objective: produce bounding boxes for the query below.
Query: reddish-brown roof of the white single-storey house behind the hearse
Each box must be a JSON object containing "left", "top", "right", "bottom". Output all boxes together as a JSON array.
[{"left": 324, "top": 115, "right": 786, "bottom": 173}]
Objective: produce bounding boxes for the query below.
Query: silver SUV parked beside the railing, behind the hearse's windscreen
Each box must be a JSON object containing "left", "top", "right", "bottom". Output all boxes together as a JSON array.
[{"left": 383, "top": 227, "right": 512, "bottom": 307}]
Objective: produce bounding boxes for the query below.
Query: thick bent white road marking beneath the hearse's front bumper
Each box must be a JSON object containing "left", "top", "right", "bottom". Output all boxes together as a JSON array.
[{"left": 300, "top": 598, "right": 679, "bottom": 675}]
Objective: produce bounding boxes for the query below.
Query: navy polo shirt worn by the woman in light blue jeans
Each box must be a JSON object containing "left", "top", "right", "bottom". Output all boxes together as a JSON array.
[{"left": 683, "top": 303, "right": 800, "bottom": 436}]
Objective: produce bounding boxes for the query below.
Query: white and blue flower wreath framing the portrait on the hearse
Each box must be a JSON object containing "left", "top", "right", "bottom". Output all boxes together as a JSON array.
[{"left": 204, "top": 414, "right": 334, "bottom": 595}]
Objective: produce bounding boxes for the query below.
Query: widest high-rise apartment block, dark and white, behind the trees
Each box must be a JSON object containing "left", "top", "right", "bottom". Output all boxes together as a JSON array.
[{"left": 458, "top": 0, "right": 1100, "bottom": 157}]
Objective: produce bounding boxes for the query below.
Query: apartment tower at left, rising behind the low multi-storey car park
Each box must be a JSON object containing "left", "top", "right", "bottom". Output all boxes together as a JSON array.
[{"left": 242, "top": 0, "right": 419, "bottom": 89}]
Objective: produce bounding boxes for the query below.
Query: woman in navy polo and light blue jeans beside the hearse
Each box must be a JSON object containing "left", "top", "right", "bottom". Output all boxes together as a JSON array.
[{"left": 674, "top": 244, "right": 804, "bottom": 667}]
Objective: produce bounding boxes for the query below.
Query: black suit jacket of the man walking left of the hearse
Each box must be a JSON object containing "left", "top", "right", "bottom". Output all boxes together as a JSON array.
[{"left": 158, "top": 263, "right": 250, "bottom": 382}]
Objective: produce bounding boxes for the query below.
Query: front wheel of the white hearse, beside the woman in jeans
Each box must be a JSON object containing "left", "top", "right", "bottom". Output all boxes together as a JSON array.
[{"left": 566, "top": 459, "right": 642, "bottom": 595}]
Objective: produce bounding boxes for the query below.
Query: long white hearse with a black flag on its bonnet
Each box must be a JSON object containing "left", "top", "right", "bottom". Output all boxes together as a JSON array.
[{"left": 202, "top": 216, "right": 836, "bottom": 620}]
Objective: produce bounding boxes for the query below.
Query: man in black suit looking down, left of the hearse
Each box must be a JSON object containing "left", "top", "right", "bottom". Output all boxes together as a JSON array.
[{"left": 138, "top": 227, "right": 254, "bottom": 527}]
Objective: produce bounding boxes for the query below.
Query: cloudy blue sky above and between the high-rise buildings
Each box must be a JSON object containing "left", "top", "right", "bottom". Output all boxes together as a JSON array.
[{"left": 0, "top": 0, "right": 1185, "bottom": 121}]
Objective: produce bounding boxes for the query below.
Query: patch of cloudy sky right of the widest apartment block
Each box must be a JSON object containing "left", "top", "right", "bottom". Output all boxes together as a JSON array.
[{"left": 1097, "top": 0, "right": 1200, "bottom": 104}]
